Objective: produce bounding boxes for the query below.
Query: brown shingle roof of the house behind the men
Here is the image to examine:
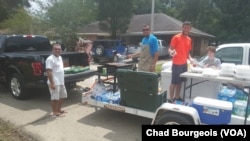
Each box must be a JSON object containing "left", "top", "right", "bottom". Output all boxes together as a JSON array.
[{"left": 80, "top": 13, "right": 215, "bottom": 38}]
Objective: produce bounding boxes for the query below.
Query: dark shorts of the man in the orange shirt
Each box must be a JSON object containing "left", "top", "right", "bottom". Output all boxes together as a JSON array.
[{"left": 171, "top": 64, "right": 187, "bottom": 84}]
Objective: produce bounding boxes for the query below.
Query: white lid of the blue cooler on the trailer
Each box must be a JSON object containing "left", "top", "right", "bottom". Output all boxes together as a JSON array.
[{"left": 193, "top": 97, "right": 233, "bottom": 110}]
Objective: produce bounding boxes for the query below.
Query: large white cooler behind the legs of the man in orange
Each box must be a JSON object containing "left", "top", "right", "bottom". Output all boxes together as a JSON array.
[{"left": 161, "top": 69, "right": 221, "bottom": 99}]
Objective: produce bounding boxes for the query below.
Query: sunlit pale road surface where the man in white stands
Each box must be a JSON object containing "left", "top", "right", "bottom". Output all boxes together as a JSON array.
[{"left": 0, "top": 60, "right": 161, "bottom": 141}]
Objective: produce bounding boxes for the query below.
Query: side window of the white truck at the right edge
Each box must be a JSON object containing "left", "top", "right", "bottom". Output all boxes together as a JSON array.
[{"left": 216, "top": 47, "right": 243, "bottom": 64}]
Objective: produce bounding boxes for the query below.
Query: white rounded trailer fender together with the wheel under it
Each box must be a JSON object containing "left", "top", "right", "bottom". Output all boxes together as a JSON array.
[{"left": 151, "top": 103, "right": 200, "bottom": 125}]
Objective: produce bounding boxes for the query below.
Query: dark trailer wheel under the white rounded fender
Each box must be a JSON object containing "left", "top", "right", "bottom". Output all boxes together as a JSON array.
[{"left": 155, "top": 112, "right": 194, "bottom": 125}]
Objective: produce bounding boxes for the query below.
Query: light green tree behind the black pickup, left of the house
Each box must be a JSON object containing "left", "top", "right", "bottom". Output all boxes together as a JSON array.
[{"left": 45, "top": 0, "right": 96, "bottom": 47}]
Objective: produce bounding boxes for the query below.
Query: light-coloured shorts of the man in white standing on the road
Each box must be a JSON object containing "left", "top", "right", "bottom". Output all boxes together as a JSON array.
[{"left": 49, "top": 85, "right": 67, "bottom": 100}]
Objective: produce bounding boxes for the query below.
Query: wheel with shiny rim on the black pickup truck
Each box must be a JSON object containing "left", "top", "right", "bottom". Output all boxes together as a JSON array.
[{"left": 9, "top": 73, "right": 27, "bottom": 99}]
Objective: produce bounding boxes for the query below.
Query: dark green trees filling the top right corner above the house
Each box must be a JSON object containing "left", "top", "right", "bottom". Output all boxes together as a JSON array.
[{"left": 166, "top": 0, "right": 250, "bottom": 42}]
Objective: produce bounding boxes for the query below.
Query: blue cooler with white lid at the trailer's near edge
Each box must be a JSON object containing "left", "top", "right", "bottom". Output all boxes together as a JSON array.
[{"left": 192, "top": 97, "right": 233, "bottom": 125}]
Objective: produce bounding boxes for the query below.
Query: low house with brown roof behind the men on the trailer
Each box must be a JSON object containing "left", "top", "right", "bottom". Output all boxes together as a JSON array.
[{"left": 78, "top": 13, "right": 215, "bottom": 56}]
